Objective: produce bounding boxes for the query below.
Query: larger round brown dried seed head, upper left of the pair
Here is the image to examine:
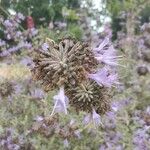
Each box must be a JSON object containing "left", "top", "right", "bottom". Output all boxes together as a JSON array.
[{"left": 32, "top": 38, "right": 97, "bottom": 91}]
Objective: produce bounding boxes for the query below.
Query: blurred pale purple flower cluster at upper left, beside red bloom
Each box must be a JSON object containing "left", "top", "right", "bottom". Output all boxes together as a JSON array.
[{"left": 0, "top": 13, "right": 38, "bottom": 58}]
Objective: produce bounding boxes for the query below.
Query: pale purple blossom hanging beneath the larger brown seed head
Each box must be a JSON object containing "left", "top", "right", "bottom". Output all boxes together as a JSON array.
[{"left": 51, "top": 87, "right": 68, "bottom": 115}]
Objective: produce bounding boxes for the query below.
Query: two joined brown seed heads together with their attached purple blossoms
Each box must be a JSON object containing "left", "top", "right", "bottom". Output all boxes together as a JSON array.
[{"left": 32, "top": 38, "right": 117, "bottom": 118}]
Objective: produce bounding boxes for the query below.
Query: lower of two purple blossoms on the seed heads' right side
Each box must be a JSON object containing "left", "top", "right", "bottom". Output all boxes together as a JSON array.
[{"left": 88, "top": 67, "right": 118, "bottom": 87}]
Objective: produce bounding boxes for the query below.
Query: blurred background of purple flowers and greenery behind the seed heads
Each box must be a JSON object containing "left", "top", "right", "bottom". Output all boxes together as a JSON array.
[{"left": 0, "top": 0, "right": 150, "bottom": 150}]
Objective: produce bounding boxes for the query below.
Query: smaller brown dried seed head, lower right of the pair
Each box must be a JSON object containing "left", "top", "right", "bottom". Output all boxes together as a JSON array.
[{"left": 67, "top": 81, "right": 110, "bottom": 114}]
